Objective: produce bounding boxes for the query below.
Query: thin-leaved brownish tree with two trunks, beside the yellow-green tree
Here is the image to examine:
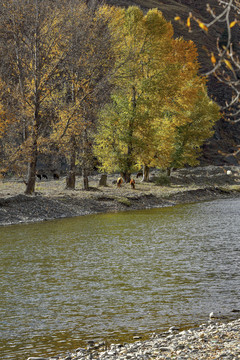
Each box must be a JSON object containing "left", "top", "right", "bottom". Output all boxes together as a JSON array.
[{"left": 52, "top": 0, "right": 114, "bottom": 190}]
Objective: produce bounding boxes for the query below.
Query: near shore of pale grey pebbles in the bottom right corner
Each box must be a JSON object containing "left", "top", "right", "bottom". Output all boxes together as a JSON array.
[{"left": 27, "top": 319, "right": 240, "bottom": 360}]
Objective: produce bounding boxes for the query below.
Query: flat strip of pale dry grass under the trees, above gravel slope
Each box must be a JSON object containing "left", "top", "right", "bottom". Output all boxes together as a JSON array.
[{"left": 0, "top": 167, "right": 240, "bottom": 199}]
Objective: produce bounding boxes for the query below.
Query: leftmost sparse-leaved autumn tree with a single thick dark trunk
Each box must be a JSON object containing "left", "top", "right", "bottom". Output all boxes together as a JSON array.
[{"left": 0, "top": 0, "right": 73, "bottom": 194}]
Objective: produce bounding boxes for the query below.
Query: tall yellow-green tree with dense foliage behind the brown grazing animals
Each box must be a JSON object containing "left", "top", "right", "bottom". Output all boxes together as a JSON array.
[{"left": 96, "top": 7, "right": 176, "bottom": 181}]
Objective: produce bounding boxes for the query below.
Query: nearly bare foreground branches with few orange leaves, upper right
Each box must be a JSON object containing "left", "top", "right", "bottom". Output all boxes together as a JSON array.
[{"left": 187, "top": 0, "right": 240, "bottom": 122}]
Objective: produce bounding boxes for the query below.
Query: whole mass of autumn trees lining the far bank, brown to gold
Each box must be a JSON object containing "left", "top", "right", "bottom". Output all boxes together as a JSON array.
[{"left": 0, "top": 0, "right": 219, "bottom": 190}]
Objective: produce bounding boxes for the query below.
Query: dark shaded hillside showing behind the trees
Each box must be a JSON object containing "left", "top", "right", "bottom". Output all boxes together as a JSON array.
[{"left": 106, "top": 0, "right": 240, "bottom": 165}]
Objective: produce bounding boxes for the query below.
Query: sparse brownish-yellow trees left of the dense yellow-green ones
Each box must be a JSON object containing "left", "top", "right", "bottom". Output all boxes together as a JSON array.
[{"left": 0, "top": 0, "right": 113, "bottom": 194}]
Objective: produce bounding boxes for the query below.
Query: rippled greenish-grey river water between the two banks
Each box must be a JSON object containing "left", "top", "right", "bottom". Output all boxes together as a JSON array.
[{"left": 0, "top": 199, "right": 240, "bottom": 360}]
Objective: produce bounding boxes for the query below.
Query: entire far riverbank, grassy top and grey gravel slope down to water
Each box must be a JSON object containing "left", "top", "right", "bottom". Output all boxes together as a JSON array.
[{"left": 0, "top": 167, "right": 240, "bottom": 225}]
